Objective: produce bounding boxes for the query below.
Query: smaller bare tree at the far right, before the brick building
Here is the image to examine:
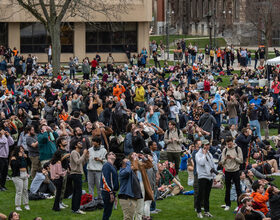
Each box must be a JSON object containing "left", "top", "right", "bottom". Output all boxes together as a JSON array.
[{"left": 244, "top": 0, "right": 280, "bottom": 59}]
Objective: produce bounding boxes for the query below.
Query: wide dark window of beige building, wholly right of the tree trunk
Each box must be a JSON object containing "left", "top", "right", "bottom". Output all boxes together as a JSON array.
[{"left": 86, "top": 22, "right": 137, "bottom": 53}]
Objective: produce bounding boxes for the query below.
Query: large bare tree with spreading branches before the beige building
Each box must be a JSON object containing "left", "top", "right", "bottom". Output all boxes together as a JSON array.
[{"left": 3, "top": 0, "right": 129, "bottom": 74}]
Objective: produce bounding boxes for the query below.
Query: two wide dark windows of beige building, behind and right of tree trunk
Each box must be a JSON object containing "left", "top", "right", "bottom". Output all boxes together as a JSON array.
[{"left": 20, "top": 23, "right": 137, "bottom": 53}]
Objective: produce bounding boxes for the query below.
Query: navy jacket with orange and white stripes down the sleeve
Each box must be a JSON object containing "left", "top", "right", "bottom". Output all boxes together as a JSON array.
[{"left": 100, "top": 162, "right": 119, "bottom": 192}]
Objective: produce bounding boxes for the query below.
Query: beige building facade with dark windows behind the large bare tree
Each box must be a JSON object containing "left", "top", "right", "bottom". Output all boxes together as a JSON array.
[{"left": 0, "top": 0, "right": 152, "bottom": 62}]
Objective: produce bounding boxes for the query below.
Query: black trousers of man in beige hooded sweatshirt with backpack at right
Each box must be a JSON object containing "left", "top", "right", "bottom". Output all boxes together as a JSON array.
[{"left": 225, "top": 171, "right": 241, "bottom": 206}]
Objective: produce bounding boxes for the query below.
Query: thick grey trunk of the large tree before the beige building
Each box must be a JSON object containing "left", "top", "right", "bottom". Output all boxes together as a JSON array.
[{"left": 49, "top": 22, "right": 61, "bottom": 77}]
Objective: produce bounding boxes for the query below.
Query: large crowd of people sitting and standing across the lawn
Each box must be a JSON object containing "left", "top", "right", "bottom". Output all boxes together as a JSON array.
[{"left": 0, "top": 42, "right": 280, "bottom": 220}]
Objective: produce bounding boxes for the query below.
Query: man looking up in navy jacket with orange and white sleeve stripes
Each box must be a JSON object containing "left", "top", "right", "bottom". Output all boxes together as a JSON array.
[{"left": 100, "top": 152, "right": 119, "bottom": 220}]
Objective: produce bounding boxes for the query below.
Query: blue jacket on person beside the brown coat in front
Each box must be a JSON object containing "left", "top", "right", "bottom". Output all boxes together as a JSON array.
[{"left": 119, "top": 161, "right": 135, "bottom": 198}]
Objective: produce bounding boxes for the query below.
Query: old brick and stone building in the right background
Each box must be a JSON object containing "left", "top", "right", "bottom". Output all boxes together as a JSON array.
[{"left": 153, "top": 0, "right": 280, "bottom": 46}]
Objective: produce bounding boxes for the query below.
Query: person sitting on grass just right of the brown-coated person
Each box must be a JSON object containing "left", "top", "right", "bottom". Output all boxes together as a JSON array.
[{"left": 158, "top": 163, "right": 184, "bottom": 199}]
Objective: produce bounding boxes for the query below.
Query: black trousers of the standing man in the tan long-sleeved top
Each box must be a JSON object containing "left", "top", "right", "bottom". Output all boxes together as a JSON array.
[{"left": 71, "top": 174, "right": 82, "bottom": 212}]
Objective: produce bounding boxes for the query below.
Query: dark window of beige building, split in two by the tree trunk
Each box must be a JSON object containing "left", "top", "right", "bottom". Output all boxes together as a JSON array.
[{"left": 20, "top": 23, "right": 74, "bottom": 53}]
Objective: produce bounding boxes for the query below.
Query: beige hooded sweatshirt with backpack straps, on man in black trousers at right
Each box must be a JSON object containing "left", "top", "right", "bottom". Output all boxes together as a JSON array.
[{"left": 221, "top": 146, "right": 243, "bottom": 172}]
